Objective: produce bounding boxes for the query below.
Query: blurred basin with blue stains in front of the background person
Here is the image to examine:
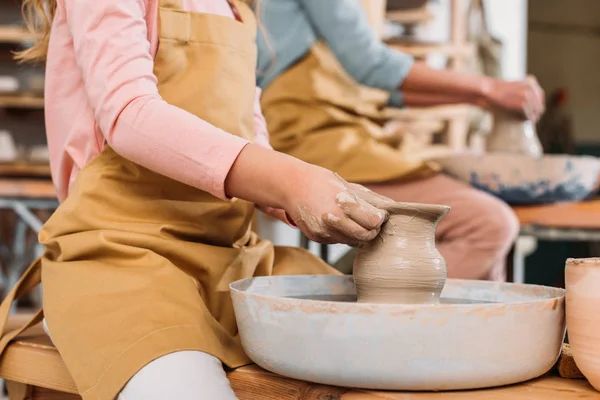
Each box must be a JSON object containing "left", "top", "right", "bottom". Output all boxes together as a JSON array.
[{"left": 436, "top": 153, "right": 600, "bottom": 205}]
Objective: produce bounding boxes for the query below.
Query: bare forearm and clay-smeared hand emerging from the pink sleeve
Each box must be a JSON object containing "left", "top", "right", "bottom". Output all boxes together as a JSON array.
[{"left": 224, "top": 144, "right": 391, "bottom": 245}]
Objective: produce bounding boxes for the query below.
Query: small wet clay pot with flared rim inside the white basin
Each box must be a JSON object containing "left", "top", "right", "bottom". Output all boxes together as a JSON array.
[{"left": 354, "top": 203, "right": 450, "bottom": 304}]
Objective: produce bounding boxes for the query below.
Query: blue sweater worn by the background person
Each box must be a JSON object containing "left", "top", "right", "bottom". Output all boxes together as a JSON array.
[{"left": 257, "top": 0, "right": 413, "bottom": 107}]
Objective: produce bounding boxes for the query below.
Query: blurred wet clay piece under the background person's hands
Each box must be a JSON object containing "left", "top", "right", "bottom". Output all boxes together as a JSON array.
[{"left": 487, "top": 111, "right": 543, "bottom": 158}]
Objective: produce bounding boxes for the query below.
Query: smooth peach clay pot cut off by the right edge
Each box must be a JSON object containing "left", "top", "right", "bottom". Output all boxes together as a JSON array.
[{"left": 565, "top": 258, "right": 600, "bottom": 391}]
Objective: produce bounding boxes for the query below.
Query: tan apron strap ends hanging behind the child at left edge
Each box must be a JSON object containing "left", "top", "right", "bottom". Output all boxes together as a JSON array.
[{"left": 0, "top": 257, "right": 44, "bottom": 354}]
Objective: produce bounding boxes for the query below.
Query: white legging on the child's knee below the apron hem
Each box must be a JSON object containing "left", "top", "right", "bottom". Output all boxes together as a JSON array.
[{"left": 44, "top": 320, "right": 237, "bottom": 400}]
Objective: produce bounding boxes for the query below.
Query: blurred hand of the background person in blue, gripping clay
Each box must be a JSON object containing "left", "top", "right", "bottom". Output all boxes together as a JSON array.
[{"left": 484, "top": 76, "right": 545, "bottom": 122}]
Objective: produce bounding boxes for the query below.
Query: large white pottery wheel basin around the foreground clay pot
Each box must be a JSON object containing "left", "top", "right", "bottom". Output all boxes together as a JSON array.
[{"left": 231, "top": 276, "right": 565, "bottom": 390}]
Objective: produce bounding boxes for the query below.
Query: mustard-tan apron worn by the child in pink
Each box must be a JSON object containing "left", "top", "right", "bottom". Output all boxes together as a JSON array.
[{"left": 0, "top": 0, "right": 335, "bottom": 400}]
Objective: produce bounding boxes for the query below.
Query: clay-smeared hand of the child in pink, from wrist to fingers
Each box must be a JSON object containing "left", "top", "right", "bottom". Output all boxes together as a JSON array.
[{"left": 285, "top": 166, "right": 391, "bottom": 246}]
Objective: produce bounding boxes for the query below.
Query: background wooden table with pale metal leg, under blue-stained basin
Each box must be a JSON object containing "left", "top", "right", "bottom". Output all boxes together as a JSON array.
[{"left": 512, "top": 199, "right": 600, "bottom": 283}]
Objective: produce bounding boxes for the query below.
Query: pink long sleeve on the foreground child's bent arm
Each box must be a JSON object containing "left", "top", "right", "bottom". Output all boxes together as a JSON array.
[{"left": 65, "top": 0, "right": 247, "bottom": 198}]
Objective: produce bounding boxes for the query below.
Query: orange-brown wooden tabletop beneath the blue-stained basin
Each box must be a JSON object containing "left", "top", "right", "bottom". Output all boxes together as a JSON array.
[{"left": 514, "top": 200, "right": 600, "bottom": 229}]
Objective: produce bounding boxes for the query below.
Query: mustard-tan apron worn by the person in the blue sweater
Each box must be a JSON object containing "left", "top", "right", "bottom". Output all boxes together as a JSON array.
[{"left": 261, "top": 42, "right": 439, "bottom": 183}]
